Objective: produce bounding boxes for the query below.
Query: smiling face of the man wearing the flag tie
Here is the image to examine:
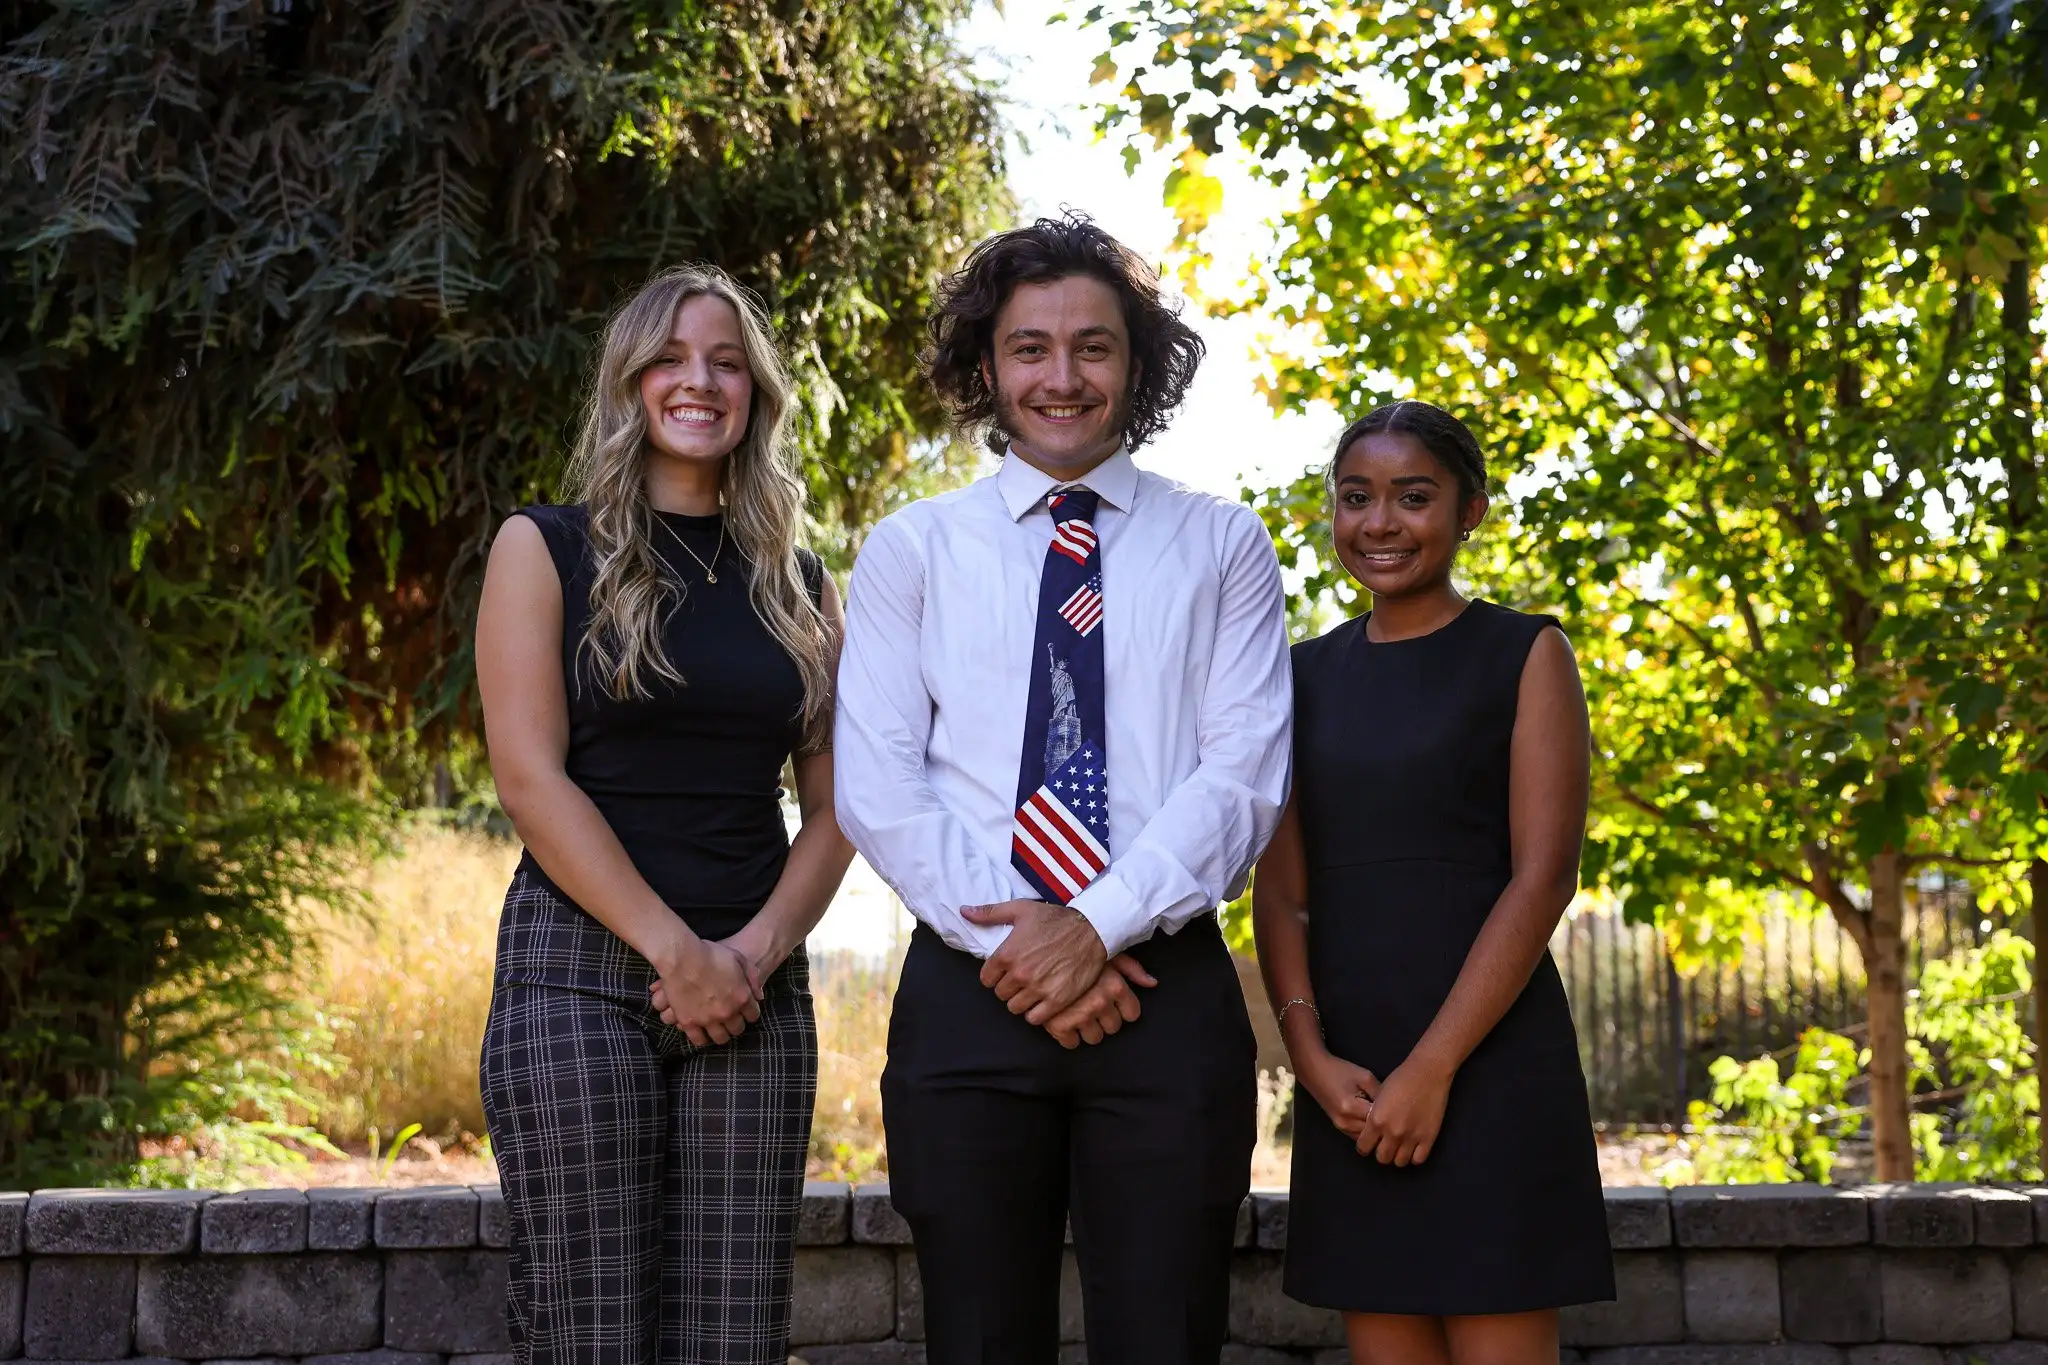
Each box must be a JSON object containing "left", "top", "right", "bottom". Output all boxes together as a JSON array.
[{"left": 983, "top": 274, "right": 1135, "bottom": 479}]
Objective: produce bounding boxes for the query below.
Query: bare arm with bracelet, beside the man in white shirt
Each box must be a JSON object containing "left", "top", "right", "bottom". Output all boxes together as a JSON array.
[{"left": 1251, "top": 796, "right": 1378, "bottom": 1138}]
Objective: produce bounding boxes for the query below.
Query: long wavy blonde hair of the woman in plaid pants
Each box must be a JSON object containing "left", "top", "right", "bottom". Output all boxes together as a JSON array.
[{"left": 561, "top": 266, "right": 838, "bottom": 751}]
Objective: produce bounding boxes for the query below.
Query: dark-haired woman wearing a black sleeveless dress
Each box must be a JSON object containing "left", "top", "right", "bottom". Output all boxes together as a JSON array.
[{"left": 1253, "top": 403, "right": 1614, "bottom": 1365}]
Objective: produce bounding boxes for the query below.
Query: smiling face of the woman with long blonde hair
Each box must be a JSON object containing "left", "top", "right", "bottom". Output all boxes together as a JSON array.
[{"left": 641, "top": 295, "right": 754, "bottom": 474}]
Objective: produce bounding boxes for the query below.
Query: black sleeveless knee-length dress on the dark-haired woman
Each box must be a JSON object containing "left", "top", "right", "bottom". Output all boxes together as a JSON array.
[{"left": 1284, "top": 602, "right": 1614, "bottom": 1316}]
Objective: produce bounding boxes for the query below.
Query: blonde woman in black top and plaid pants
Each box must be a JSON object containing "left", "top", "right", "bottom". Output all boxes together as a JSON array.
[{"left": 477, "top": 266, "right": 852, "bottom": 1365}]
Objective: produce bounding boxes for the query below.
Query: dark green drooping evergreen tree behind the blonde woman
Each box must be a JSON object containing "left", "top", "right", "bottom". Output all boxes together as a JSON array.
[{"left": 0, "top": 0, "right": 1006, "bottom": 1183}]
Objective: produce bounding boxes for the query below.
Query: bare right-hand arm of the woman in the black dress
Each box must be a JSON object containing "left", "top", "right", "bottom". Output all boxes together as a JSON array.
[{"left": 1358, "top": 630, "right": 1593, "bottom": 1166}]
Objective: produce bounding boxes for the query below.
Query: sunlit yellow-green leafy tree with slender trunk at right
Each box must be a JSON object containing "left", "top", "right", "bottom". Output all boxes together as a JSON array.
[{"left": 1098, "top": 0, "right": 2048, "bottom": 1179}]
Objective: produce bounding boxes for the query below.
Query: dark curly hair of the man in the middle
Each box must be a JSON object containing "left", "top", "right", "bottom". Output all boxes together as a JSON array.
[{"left": 920, "top": 213, "right": 1206, "bottom": 454}]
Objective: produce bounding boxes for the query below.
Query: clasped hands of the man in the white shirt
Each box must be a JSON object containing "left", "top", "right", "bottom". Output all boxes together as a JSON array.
[{"left": 961, "top": 900, "right": 1159, "bottom": 1050}]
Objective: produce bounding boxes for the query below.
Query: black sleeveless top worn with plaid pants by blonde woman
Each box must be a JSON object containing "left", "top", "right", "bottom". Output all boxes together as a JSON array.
[{"left": 514, "top": 505, "right": 825, "bottom": 939}]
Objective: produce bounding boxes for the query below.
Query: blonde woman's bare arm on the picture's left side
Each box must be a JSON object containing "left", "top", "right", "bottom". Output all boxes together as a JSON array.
[{"left": 477, "top": 516, "right": 760, "bottom": 1044}]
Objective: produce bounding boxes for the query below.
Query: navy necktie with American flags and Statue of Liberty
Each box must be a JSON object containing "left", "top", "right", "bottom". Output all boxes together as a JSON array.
[{"left": 1010, "top": 489, "right": 1110, "bottom": 905}]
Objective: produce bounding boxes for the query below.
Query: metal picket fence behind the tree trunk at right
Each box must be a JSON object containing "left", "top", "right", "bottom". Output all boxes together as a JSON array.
[{"left": 1550, "top": 872, "right": 1991, "bottom": 1124}]
